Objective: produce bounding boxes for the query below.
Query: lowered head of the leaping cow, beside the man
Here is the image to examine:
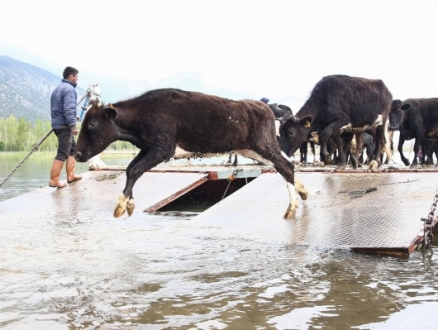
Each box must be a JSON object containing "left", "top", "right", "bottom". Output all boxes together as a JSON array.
[{"left": 75, "top": 102, "right": 119, "bottom": 162}]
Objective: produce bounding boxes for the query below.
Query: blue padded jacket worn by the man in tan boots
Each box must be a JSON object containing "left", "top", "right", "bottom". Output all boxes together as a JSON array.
[{"left": 50, "top": 79, "right": 78, "bottom": 129}]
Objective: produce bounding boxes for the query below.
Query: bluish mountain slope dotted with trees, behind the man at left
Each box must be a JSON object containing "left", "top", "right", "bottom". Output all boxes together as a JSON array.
[{"left": 0, "top": 56, "right": 85, "bottom": 123}]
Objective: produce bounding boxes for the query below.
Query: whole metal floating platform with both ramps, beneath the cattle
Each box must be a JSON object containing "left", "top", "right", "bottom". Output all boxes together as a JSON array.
[{"left": 0, "top": 165, "right": 438, "bottom": 255}]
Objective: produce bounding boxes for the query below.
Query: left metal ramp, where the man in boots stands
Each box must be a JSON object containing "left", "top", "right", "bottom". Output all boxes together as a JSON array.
[{"left": 0, "top": 171, "right": 208, "bottom": 217}]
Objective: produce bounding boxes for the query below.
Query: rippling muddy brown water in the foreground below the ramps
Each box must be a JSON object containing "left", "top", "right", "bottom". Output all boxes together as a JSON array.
[{"left": 0, "top": 157, "right": 438, "bottom": 329}]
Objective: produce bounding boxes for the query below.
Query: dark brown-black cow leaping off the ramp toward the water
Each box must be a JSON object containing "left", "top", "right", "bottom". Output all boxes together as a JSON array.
[{"left": 75, "top": 89, "right": 307, "bottom": 218}]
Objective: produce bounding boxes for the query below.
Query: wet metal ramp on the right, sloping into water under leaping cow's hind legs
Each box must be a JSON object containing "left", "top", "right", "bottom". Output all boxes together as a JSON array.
[{"left": 188, "top": 172, "right": 438, "bottom": 254}]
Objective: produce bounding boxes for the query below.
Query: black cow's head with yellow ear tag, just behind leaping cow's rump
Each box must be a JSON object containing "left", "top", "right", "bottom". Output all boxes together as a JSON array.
[{"left": 280, "top": 115, "right": 313, "bottom": 157}]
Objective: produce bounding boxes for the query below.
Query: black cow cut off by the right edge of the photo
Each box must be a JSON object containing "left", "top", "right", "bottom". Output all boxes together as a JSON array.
[{"left": 389, "top": 98, "right": 438, "bottom": 167}]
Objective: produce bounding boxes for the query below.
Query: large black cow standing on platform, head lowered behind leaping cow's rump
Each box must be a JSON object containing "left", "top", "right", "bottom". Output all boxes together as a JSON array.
[{"left": 280, "top": 75, "right": 392, "bottom": 169}]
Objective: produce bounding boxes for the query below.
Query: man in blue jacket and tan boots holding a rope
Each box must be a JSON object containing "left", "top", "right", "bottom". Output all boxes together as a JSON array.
[{"left": 49, "top": 66, "right": 82, "bottom": 188}]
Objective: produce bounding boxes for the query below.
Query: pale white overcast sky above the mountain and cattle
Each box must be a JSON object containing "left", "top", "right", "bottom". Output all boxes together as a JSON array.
[{"left": 0, "top": 0, "right": 438, "bottom": 110}]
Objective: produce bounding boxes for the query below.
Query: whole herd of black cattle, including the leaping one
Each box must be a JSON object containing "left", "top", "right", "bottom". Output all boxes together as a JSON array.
[{"left": 75, "top": 75, "right": 438, "bottom": 218}]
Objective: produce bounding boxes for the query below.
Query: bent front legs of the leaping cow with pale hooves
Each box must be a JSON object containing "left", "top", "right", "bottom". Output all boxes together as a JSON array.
[{"left": 114, "top": 136, "right": 175, "bottom": 218}]
